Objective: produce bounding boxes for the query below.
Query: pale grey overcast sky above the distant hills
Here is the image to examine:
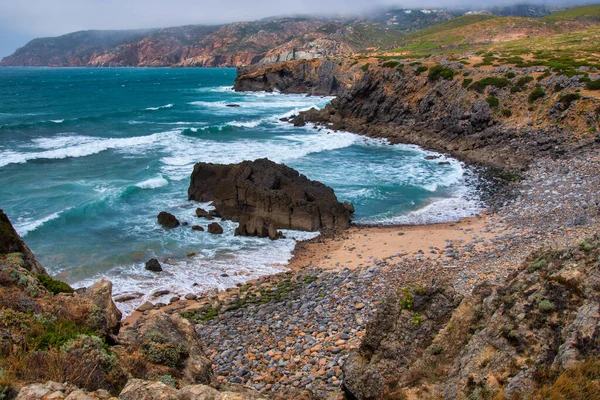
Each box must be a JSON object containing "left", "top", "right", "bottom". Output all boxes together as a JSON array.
[{"left": 0, "top": 0, "right": 600, "bottom": 57}]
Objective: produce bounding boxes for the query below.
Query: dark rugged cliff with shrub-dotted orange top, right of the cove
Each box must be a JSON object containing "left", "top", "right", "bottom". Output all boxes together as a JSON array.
[{"left": 234, "top": 54, "right": 600, "bottom": 171}]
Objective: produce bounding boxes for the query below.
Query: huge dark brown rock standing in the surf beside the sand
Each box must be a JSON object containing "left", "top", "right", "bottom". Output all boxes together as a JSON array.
[{"left": 188, "top": 159, "right": 350, "bottom": 237}]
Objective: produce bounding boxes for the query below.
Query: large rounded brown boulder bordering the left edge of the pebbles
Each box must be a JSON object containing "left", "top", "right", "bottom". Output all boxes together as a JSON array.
[{"left": 119, "top": 312, "right": 215, "bottom": 384}]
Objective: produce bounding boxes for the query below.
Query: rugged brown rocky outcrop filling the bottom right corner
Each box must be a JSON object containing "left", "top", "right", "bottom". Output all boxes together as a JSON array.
[{"left": 344, "top": 237, "right": 600, "bottom": 399}]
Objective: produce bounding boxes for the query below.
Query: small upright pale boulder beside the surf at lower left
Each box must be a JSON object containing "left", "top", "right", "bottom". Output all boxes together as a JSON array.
[{"left": 80, "top": 279, "right": 123, "bottom": 337}]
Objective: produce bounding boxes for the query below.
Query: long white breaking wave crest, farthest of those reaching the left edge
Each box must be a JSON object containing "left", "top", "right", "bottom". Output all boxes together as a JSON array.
[{"left": 0, "top": 133, "right": 170, "bottom": 167}]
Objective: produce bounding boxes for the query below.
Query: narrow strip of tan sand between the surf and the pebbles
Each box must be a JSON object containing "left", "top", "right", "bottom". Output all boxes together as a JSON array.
[{"left": 121, "top": 210, "right": 491, "bottom": 328}]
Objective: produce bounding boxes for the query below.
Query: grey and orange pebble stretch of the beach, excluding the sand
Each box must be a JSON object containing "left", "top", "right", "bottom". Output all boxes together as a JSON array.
[{"left": 196, "top": 149, "right": 600, "bottom": 398}]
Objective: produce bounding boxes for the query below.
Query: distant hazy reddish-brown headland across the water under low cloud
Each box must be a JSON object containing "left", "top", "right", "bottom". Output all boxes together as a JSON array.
[{"left": 0, "top": 18, "right": 400, "bottom": 67}]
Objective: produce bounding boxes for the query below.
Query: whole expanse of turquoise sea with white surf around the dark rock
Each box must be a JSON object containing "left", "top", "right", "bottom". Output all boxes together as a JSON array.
[{"left": 0, "top": 68, "right": 479, "bottom": 311}]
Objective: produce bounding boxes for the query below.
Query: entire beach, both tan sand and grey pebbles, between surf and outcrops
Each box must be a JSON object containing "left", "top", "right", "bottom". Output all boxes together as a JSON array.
[{"left": 115, "top": 151, "right": 600, "bottom": 398}]
